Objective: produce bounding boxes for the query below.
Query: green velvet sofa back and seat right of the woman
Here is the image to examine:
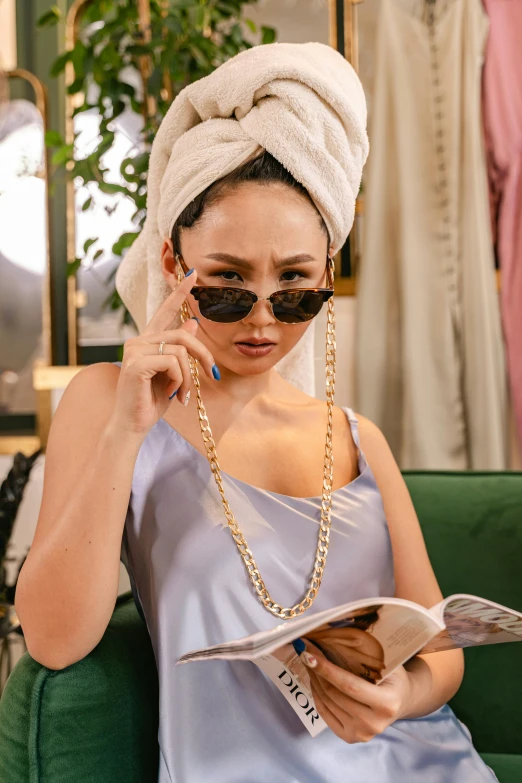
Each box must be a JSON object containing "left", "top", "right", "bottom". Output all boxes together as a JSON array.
[{"left": 403, "top": 471, "right": 522, "bottom": 783}]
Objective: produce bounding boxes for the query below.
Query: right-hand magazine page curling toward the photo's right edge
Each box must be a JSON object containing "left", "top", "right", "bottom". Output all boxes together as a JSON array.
[{"left": 421, "top": 593, "right": 522, "bottom": 654}]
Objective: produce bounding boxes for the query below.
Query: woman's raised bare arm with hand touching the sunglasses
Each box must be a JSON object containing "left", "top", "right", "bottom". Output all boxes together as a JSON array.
[{"left": 15, "top": 266, "right": 214, "bottom": 669}]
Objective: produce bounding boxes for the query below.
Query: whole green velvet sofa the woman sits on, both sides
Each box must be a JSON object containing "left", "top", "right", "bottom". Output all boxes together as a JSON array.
[{"left": 0, "top": 471, "right": 522, "bottom": 783}]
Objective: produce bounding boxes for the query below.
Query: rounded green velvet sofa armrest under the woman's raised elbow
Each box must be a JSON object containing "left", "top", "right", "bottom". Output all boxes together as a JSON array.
[{"left": 0, "top": 592, "right": 159, "bottom": 783}]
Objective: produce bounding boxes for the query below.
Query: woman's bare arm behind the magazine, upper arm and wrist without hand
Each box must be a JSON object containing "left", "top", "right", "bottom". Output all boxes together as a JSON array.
[{"left": 357, "top": 415, "right": 464, "bottom": 718}]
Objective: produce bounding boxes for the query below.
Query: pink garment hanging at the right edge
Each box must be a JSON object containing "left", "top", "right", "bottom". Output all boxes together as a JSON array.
[{"left": 483, "top": 0, "right": 522, "bottom": 446}]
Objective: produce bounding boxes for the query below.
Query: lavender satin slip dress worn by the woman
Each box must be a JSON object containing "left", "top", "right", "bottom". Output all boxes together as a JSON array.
[{"left": 117, "top": 364, "right": 497, "bottom": 783}]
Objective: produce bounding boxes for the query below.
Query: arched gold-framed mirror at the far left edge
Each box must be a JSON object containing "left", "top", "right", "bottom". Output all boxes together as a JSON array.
[{"left": 0, "top": 68, "right": 54, "bottom": 455}]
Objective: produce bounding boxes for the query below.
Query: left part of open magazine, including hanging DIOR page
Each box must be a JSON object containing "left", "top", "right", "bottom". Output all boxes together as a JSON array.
[{"left": 178, "top": 598, "right": 444, "bottom": 737}]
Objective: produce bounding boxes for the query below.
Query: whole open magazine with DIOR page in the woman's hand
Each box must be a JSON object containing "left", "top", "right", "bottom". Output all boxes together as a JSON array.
[{"left": 178, "top": 593, "right": 522, "bottom": 737}]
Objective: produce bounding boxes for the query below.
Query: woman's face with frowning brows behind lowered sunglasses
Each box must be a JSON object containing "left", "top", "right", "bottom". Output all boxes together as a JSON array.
[{"left": 162, "top": 183, "right": 331, "bottom": 382}]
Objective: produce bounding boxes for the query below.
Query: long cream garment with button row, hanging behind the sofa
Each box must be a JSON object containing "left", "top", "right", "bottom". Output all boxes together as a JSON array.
[{"left": 355, "top": 0, "right": 508, "bottom": 470}]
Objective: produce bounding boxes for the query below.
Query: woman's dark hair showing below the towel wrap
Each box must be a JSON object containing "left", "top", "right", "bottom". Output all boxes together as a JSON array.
[{"left": 172, "top": 150, "right": 328, "bottom": 253}]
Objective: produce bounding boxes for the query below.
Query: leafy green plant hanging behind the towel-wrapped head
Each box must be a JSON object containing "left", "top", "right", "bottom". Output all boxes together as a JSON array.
[{"left": 38, "top": 0, "right": 276, "bottom": 324}]
